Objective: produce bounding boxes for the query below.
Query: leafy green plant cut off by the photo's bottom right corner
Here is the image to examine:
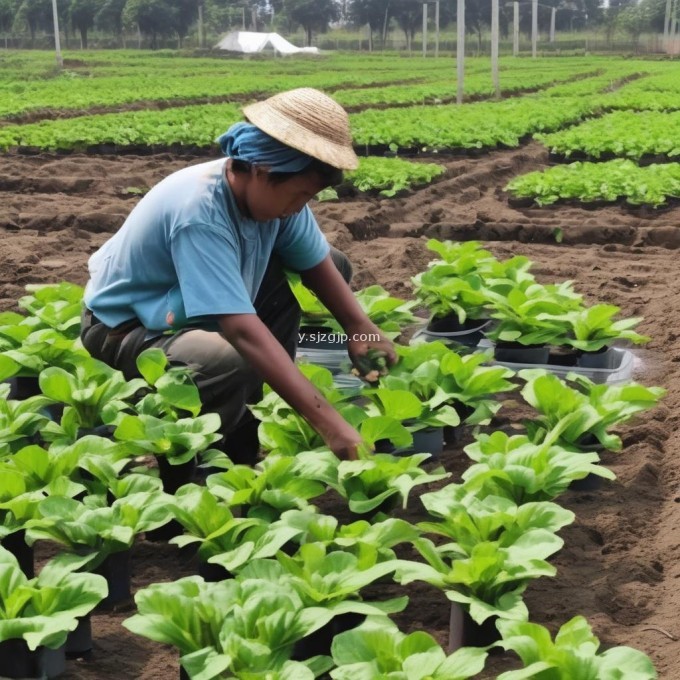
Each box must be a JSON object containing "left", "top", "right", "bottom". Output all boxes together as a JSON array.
[{"left": 498, "top": 616, "right": 658, "bottom": 680}]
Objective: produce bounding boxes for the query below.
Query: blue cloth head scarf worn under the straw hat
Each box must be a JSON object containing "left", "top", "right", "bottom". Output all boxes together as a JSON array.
[{"left": 217, "top": 123, "right": 313, "bottom": 172}]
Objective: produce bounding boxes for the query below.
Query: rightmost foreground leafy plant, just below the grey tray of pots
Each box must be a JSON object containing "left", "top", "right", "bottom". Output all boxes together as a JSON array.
[{"left": 520, "top": 370, "right": 666, "bottom": 451}]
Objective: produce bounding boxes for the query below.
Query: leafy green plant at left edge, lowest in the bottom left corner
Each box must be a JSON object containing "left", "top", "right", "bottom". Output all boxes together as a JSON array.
[{"left": 0, "top": 546, "right": 107, "bottom": 650}]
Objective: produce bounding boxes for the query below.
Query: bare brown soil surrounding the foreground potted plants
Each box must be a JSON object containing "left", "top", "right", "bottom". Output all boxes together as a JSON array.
[{"left": 5, "top": 144, "right": 680, "bottom": 680}]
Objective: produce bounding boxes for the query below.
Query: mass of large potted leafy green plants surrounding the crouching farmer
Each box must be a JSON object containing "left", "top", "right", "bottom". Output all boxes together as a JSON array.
[{"left": 0, "top": 242, "right": 663, "bottom": 680}]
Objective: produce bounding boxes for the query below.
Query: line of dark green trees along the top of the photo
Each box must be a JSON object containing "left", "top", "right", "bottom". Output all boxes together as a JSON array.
[{"left": 0, "top": 0, "right": 680, "bottom": 48}]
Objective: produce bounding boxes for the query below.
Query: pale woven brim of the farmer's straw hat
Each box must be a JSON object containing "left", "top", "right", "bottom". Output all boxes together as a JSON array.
[{"left": 243, "top": 100, "right": 359, "bottom": 170}]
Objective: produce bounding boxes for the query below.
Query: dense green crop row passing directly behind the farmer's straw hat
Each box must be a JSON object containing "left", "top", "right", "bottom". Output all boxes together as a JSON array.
[{"left": 0, "top": 97, "right": 590, "bottom": 150}]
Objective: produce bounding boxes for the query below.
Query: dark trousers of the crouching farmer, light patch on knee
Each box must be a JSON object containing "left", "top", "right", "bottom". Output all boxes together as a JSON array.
[{"left": 81, "top": 248, "right": 352, "bottom": 435}]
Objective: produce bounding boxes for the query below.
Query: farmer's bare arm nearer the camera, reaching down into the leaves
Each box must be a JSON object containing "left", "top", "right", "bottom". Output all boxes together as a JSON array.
[{"left": 219, "top": 314, "right": 362, "bottom": 459}]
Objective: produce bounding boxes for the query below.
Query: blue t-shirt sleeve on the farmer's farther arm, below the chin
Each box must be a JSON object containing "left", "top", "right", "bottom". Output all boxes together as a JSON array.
[{"left": 275, "top": 206, "right": 330, "bottom": 271}]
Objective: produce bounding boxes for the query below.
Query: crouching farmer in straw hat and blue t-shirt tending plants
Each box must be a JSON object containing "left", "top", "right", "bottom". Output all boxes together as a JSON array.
[{"left": 81, "top": 88, "right": 396, "bottom": 463}]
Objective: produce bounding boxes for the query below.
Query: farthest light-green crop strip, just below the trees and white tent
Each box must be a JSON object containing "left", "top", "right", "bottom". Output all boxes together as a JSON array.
[{"left": 0, "top": 55, "right": 634, "bottom": 117}]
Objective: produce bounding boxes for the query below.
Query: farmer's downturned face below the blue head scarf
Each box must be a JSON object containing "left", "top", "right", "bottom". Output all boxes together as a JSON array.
[{"left": 244, "top": 168, "right": 323, "bottom": 222}]
